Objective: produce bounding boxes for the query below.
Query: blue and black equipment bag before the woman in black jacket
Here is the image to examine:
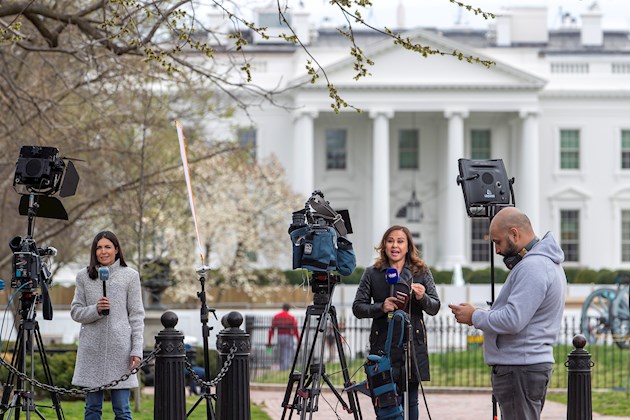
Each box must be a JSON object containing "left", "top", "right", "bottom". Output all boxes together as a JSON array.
[{"left": 346, "top": 309, "right": 405, "bottom": 420}]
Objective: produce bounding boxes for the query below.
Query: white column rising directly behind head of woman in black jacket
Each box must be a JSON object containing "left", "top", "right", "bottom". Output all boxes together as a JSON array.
[{"left": 370, "top": 110, "right": 394, "bottom": 253}]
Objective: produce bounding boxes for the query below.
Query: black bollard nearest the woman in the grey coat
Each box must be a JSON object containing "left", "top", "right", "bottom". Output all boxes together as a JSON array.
[{"left": 153, "top": 311, "right": 186, "bottom": 420}]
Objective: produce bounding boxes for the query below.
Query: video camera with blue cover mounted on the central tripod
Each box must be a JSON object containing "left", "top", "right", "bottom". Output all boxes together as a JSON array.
[{"left": 289, "top": 190, "right": 356, "bottom": 292}]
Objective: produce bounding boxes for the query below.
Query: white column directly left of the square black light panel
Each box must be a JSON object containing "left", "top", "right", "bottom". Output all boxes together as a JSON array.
[{"left": 439, "top": 109, "right": 468, "bottom": 270}]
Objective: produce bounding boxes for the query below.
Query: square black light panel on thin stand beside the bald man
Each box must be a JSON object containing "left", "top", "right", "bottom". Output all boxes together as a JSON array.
[{"left": 457, "top": 159, "right": 516, "bottom": 420}]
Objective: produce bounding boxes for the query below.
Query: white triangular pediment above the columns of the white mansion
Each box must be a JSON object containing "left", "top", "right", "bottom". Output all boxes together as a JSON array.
[{"left": 296, "top": 29, "right": 546, "bottom": 90}]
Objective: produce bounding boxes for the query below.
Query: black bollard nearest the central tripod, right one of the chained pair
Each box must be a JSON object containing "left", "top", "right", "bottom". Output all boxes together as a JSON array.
[{"left": 217, "top": 312, "right": 251, "bottom": 420}]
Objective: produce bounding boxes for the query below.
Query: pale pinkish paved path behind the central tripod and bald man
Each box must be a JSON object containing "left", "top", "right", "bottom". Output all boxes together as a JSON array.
[{"left": 251, "top": 384, "right": 630, "bottom": 420}]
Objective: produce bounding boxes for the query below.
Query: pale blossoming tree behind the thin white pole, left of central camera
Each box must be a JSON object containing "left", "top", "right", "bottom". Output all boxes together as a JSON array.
[{"left": 169, "top": 151, "right": 304, "bottom": 298}]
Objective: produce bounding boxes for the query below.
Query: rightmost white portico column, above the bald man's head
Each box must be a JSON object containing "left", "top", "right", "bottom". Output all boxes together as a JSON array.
[{"left": 514, "top": 110, "right": 544, "bottom": 230}]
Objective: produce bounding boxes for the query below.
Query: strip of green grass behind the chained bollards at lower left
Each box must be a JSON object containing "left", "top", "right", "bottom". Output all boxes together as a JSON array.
[{"left": 38, "top": 395, "right": 271, "bottom": 420}]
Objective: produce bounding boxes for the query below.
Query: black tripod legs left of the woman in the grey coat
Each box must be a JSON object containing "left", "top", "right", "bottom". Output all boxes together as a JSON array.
[{"left": 0, "top": 292, "right": 65, "bottom": 420}]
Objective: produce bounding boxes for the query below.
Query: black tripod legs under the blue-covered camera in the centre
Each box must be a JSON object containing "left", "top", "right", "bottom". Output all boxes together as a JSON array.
[{"left": 282, "top": 272, "right": 362, "bottom": 420}]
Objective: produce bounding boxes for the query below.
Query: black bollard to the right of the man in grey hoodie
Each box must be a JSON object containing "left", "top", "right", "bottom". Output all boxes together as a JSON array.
[{"left": 565, "top": 334, "right": 593, "bottom": 420}]
